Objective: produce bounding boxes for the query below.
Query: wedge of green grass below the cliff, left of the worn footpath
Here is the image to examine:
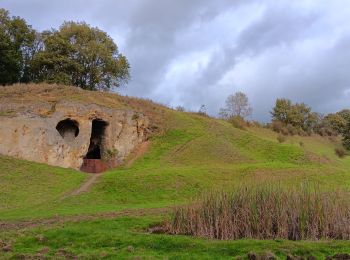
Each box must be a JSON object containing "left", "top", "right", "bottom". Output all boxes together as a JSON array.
[{"left": 0, "top": 156, "right": 87, "bottom": 218}]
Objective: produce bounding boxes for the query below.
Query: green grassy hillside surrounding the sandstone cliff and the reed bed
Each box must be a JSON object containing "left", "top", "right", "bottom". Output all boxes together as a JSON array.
[{"left": 0, "top": 85, "right": 350, "bottom": 259}]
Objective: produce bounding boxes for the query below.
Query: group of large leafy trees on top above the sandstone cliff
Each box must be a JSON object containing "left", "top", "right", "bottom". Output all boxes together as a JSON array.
[{"left": 0, "top": 9, "right": 130, "bottom": 90}]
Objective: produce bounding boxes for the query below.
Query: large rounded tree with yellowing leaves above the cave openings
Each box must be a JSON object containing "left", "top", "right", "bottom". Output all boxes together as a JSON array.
[{"left": 31, "top": 22, "right": 130, "bottom": 90}]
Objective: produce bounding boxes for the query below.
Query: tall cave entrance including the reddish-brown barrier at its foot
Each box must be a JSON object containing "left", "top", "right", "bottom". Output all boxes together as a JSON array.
[{"left": 81, "top": 119, "right": 108, "bottom": 173}]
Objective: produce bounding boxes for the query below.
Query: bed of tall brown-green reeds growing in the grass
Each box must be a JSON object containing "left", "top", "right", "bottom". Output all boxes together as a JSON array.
[{"left": 164, "top": 185, "right": 350, "bottom": 240}]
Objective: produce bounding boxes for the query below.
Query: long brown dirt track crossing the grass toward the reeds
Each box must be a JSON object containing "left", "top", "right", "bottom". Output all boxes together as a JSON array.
[{"left": 0, "top": 208, "right": 171, "bottom": 232}]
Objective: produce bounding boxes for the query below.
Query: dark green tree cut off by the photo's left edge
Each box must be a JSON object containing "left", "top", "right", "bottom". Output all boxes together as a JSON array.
[{"left": 0, "top": 9, "right": 35, "bottom": 85}]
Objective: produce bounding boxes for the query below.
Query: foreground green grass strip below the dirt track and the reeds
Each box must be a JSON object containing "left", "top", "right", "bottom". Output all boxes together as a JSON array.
[{"left": 0, "top": 216, "right": 350, "bottom": 259}]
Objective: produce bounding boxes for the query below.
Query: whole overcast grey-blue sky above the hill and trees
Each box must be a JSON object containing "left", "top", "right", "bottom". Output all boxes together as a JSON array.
[{"left": 0, "top": 0, "right": 350, "bottom": 120}]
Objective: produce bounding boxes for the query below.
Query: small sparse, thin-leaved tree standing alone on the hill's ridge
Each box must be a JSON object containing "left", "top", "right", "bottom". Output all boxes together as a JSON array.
[{"left": 219, "top": 92, "right": 253, "bottom": 119}]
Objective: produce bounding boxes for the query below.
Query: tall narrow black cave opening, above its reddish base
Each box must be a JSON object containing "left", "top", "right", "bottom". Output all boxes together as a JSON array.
[{"left": 84, "top": 119, "right": 108, "bottom": 159}]
